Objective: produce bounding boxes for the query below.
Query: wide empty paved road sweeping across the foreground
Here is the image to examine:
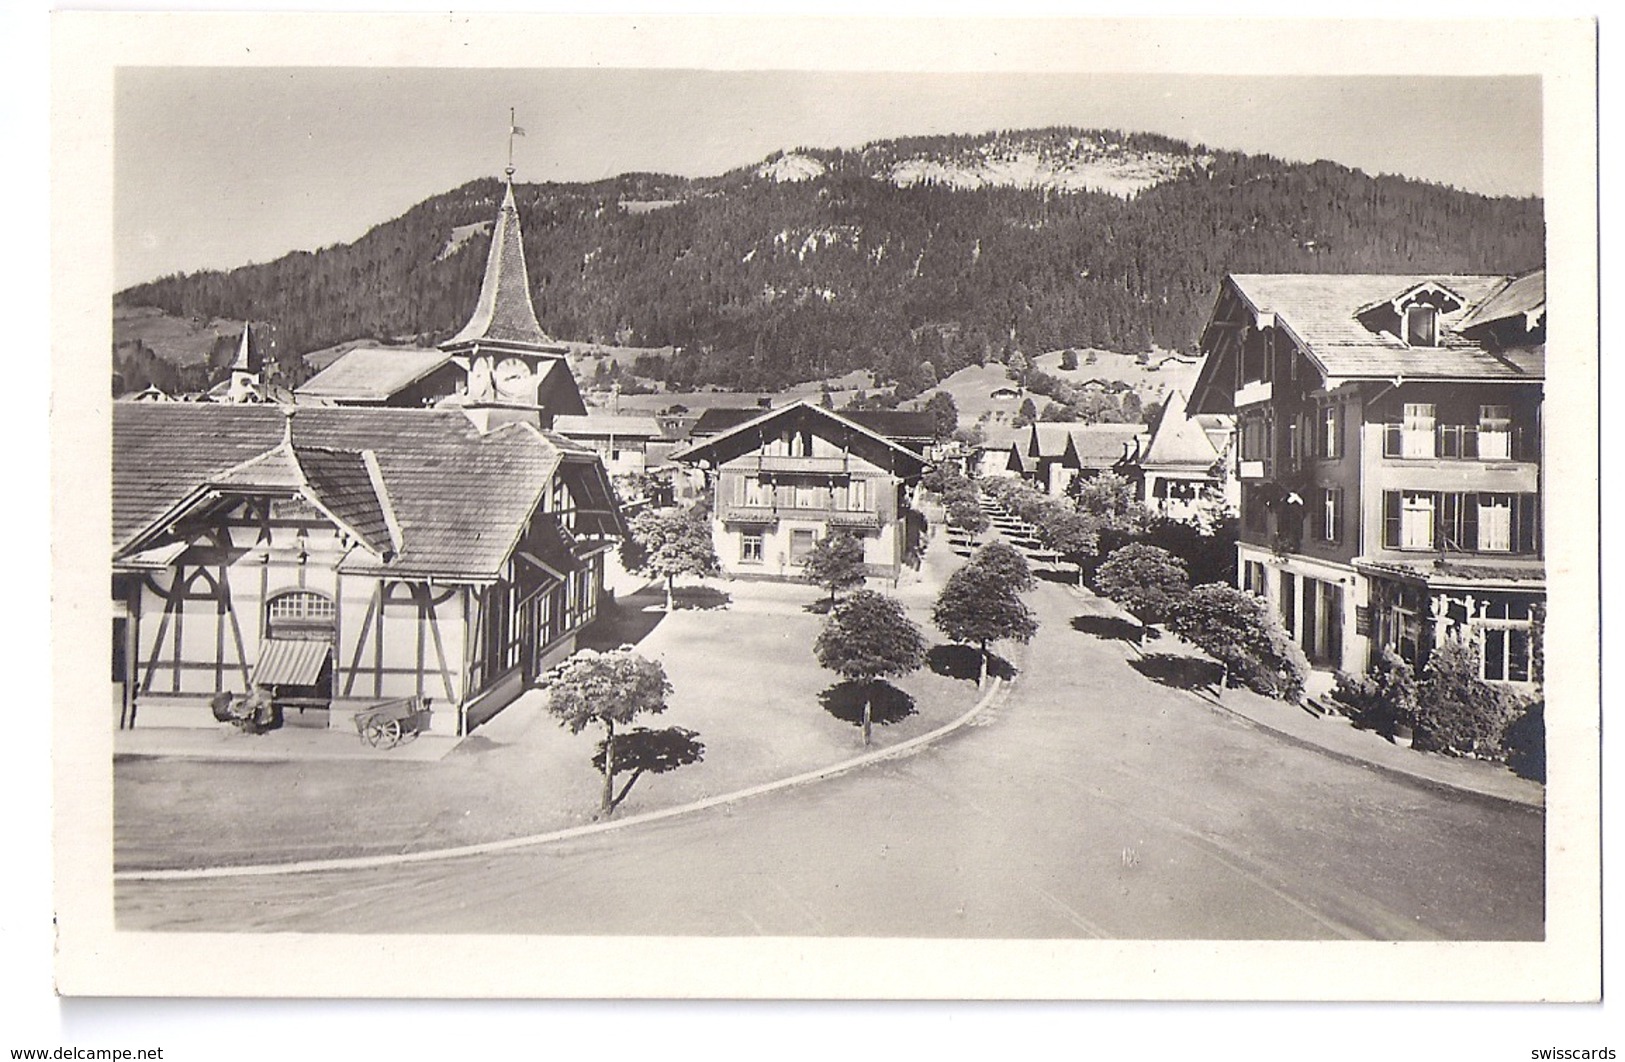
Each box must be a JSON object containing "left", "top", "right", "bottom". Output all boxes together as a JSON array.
[{"left": 115, "top": 583, "right": 1544, "bottom": 940}]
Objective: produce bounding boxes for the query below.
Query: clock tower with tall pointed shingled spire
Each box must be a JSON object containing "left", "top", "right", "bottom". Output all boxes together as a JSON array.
[{"left": 440, "top": 166, "right": 587, "bottom": 429}]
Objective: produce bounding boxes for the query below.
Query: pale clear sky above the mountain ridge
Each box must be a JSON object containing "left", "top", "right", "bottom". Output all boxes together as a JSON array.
[{"left": 114, "top": 67, "right": 1542, "bottom": 287}]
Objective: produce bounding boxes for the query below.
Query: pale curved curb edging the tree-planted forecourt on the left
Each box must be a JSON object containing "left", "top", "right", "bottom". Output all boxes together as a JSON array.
[{"left": 112, "top": 679, "right": 1009, "bottom": 882}]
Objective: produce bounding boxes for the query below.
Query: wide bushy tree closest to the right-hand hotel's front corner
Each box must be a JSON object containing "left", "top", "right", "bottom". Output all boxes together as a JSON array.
[{"left": 1168, "top": 583, "right": 1308, "bottom": 703}]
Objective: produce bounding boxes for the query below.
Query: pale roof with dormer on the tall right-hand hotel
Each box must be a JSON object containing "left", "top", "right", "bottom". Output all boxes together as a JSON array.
[{"left": 1222, "top": 273, "right": 1545, "bottom": 380}]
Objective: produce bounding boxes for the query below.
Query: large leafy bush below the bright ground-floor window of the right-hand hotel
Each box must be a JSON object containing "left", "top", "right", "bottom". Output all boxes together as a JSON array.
[{"left": 1412, "top": 638, "right": 1518, "bottom": 760}]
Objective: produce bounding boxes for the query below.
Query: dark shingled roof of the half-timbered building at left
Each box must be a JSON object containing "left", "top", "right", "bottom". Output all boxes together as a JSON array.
[{"left": 112, "top": 403, "right": 601, "bottom": 581}]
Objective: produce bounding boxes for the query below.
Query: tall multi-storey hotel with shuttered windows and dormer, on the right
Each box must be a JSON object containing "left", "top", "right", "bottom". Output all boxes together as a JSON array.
[{"left": 1191, "top": 271, "right": 1545, "bottom": 684}]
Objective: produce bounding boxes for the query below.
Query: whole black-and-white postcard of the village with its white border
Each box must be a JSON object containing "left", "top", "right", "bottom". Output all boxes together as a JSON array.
[{"left": 31, "top": 6, "right": 1602, "bottom": 1057}]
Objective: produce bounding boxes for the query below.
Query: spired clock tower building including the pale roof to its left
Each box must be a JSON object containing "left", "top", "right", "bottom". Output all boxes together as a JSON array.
[{"left": 296, "top": 180, "right": 587, "bottom": 429}]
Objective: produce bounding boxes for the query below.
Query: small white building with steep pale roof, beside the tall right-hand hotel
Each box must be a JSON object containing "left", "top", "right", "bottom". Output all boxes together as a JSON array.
[{"left": 1131, "top": 390, "right": 1242, "bottom": 521}]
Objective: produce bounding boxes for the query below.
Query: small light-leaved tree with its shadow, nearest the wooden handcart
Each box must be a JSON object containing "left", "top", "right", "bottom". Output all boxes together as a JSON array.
[{"left": 546, "top": 650, "right": 705, "bottom": 815}]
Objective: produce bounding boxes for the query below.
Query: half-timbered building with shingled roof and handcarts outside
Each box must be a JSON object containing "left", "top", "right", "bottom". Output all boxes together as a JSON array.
[{"left": 112, "top": 403, "right": 622, "bottom": 734}]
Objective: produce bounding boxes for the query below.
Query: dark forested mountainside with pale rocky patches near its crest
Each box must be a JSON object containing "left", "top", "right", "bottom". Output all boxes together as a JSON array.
[{"left": 117, "top": 130, "right": 1544, "bottom": 390}]
